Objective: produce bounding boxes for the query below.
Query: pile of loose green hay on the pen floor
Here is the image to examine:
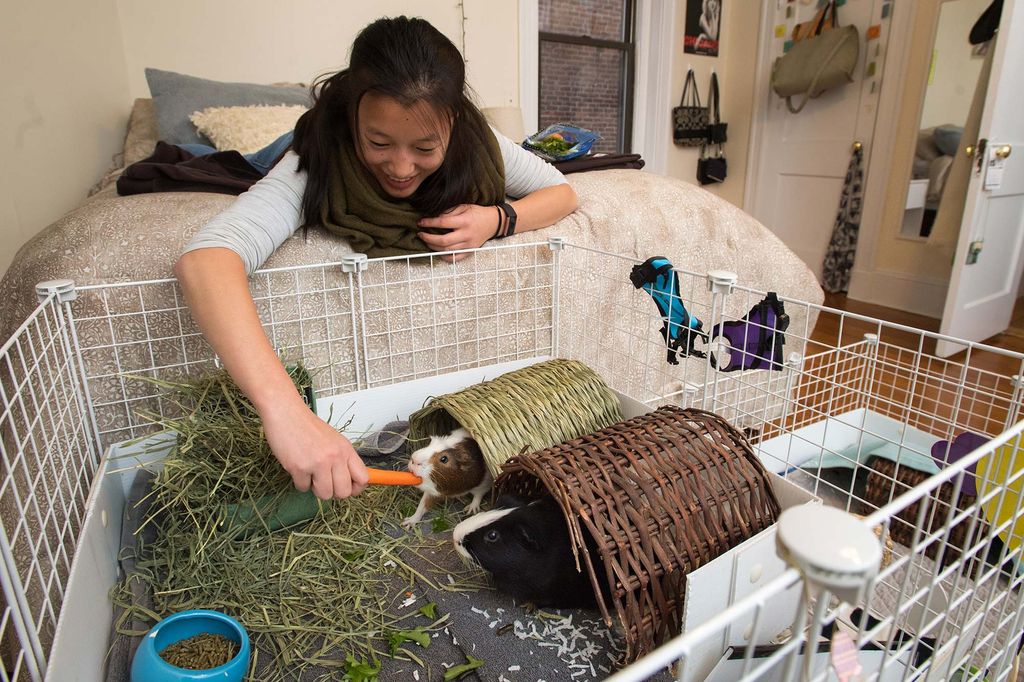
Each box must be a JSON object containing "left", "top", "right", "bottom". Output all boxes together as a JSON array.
[{"left": 111, "top": 372, "right": 484, "bottom": 681}]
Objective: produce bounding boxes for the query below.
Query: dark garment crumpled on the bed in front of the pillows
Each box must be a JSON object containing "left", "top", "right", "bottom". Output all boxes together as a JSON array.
[{"left": 118, "top": 142, "right": 263, "bottom": 196}]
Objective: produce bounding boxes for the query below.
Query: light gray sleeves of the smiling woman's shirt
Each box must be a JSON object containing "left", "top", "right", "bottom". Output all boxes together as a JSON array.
[{"left": 183, "top": 129, "right": 565, "bottom": 274}]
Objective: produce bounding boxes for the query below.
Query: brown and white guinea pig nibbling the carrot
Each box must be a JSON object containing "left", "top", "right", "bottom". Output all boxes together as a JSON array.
[{"left": 402, "top": 428, "right": 494, "bottom": 526}]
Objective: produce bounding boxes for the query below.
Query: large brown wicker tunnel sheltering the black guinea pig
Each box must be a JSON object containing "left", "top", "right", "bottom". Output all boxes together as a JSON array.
[{"left": 495, "top": 407, "right": 779, "bottom": 660}]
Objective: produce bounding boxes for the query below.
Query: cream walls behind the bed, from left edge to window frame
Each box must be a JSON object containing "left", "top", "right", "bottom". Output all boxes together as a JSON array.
[{"left": 0, "top": 0, "right": 519, "bottom": 273}]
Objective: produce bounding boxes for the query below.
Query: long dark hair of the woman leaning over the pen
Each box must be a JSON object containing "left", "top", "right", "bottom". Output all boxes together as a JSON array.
[{"left": 293, "top": 16, "right": 487, "bottom": 220}]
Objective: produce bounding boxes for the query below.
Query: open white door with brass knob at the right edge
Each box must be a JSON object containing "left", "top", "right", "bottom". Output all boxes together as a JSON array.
[{"left": 936, "top": 0, "right": 1024, "bottom": 356}]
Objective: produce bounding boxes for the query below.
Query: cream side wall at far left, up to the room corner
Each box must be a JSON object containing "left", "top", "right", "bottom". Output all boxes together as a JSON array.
[{"left": 0, "top": 0, "right": 131, "bottom": 273}]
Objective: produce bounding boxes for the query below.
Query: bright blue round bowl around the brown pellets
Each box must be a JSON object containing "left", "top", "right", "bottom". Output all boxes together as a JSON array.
[{"left": 131, "top": 609, "right": 252, "bottom": 682}]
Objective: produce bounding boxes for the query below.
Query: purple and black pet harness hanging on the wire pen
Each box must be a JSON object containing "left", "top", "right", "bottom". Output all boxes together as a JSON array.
[{"left": 709, "top": 291, "right": 790, "bottom": 372}]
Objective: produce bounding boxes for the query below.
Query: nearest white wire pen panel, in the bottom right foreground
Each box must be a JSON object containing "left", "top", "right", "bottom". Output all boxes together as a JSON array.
[{"left": 609, "top": 424, "right": 1024, "bottom": 682}]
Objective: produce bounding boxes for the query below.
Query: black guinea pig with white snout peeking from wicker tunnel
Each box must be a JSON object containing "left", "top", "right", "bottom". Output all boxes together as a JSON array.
[{"left": 453, "top": 496, "right": 608, "bottom": 608}]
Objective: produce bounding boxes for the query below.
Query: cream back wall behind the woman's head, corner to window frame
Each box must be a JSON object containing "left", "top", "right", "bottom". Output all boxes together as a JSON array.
[{"left": 118, "top": 0, "right": 518, "bottom": 106}]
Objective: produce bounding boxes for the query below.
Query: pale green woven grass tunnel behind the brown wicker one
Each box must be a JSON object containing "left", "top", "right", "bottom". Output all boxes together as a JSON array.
[{"left": 409, "top": 358, "right": 623, "bottom": 476}]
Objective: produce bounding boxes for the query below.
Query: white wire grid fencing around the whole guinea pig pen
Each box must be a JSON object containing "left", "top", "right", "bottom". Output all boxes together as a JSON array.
[{"left": 0, "top": 240, "right": 1024, "bottom": 680}]
